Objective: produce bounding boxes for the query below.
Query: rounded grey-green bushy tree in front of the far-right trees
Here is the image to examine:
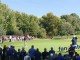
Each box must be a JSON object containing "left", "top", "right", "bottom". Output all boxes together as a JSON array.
[{"left": 60, "top": 22, "right": 75, "bottom": 35}]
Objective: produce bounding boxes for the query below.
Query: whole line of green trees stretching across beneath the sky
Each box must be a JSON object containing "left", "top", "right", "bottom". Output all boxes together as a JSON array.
[{"left": 0, "top": 2, "right": 80, "bottom": 38}]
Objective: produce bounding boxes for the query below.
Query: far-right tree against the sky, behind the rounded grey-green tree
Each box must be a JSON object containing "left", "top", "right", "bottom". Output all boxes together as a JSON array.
[{"left": 61, "top": 13, "right": 80, "bottom": 31}]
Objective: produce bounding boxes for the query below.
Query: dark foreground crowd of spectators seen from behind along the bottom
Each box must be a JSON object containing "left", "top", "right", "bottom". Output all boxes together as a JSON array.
[{"left": 0, "top": 45, "right": 80, "bottom": 60}]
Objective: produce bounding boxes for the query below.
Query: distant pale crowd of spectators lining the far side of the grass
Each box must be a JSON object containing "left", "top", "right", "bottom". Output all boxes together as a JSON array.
[{"left": 0, "top": 35, "right": 34, "bottom": 43}]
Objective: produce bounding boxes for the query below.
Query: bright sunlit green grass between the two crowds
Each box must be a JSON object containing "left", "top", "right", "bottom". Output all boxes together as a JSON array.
[{"left": 0, "top": 39, "right": 80, "bottom": 53}]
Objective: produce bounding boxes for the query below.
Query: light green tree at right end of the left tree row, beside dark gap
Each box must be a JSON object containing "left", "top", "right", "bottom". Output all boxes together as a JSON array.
[{"left": 29, "top": 15, "right": 40, "bottom": 37}]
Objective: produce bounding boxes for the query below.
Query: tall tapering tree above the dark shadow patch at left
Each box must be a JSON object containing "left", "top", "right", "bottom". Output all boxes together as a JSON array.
[{"left": 6, "top": 10, "right": 18, "bottom": 35}]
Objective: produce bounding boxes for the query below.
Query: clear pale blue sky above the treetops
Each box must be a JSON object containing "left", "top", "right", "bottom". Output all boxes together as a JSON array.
[{"left": 1, "top": 0, "right": 80, "bottom": 17}]
